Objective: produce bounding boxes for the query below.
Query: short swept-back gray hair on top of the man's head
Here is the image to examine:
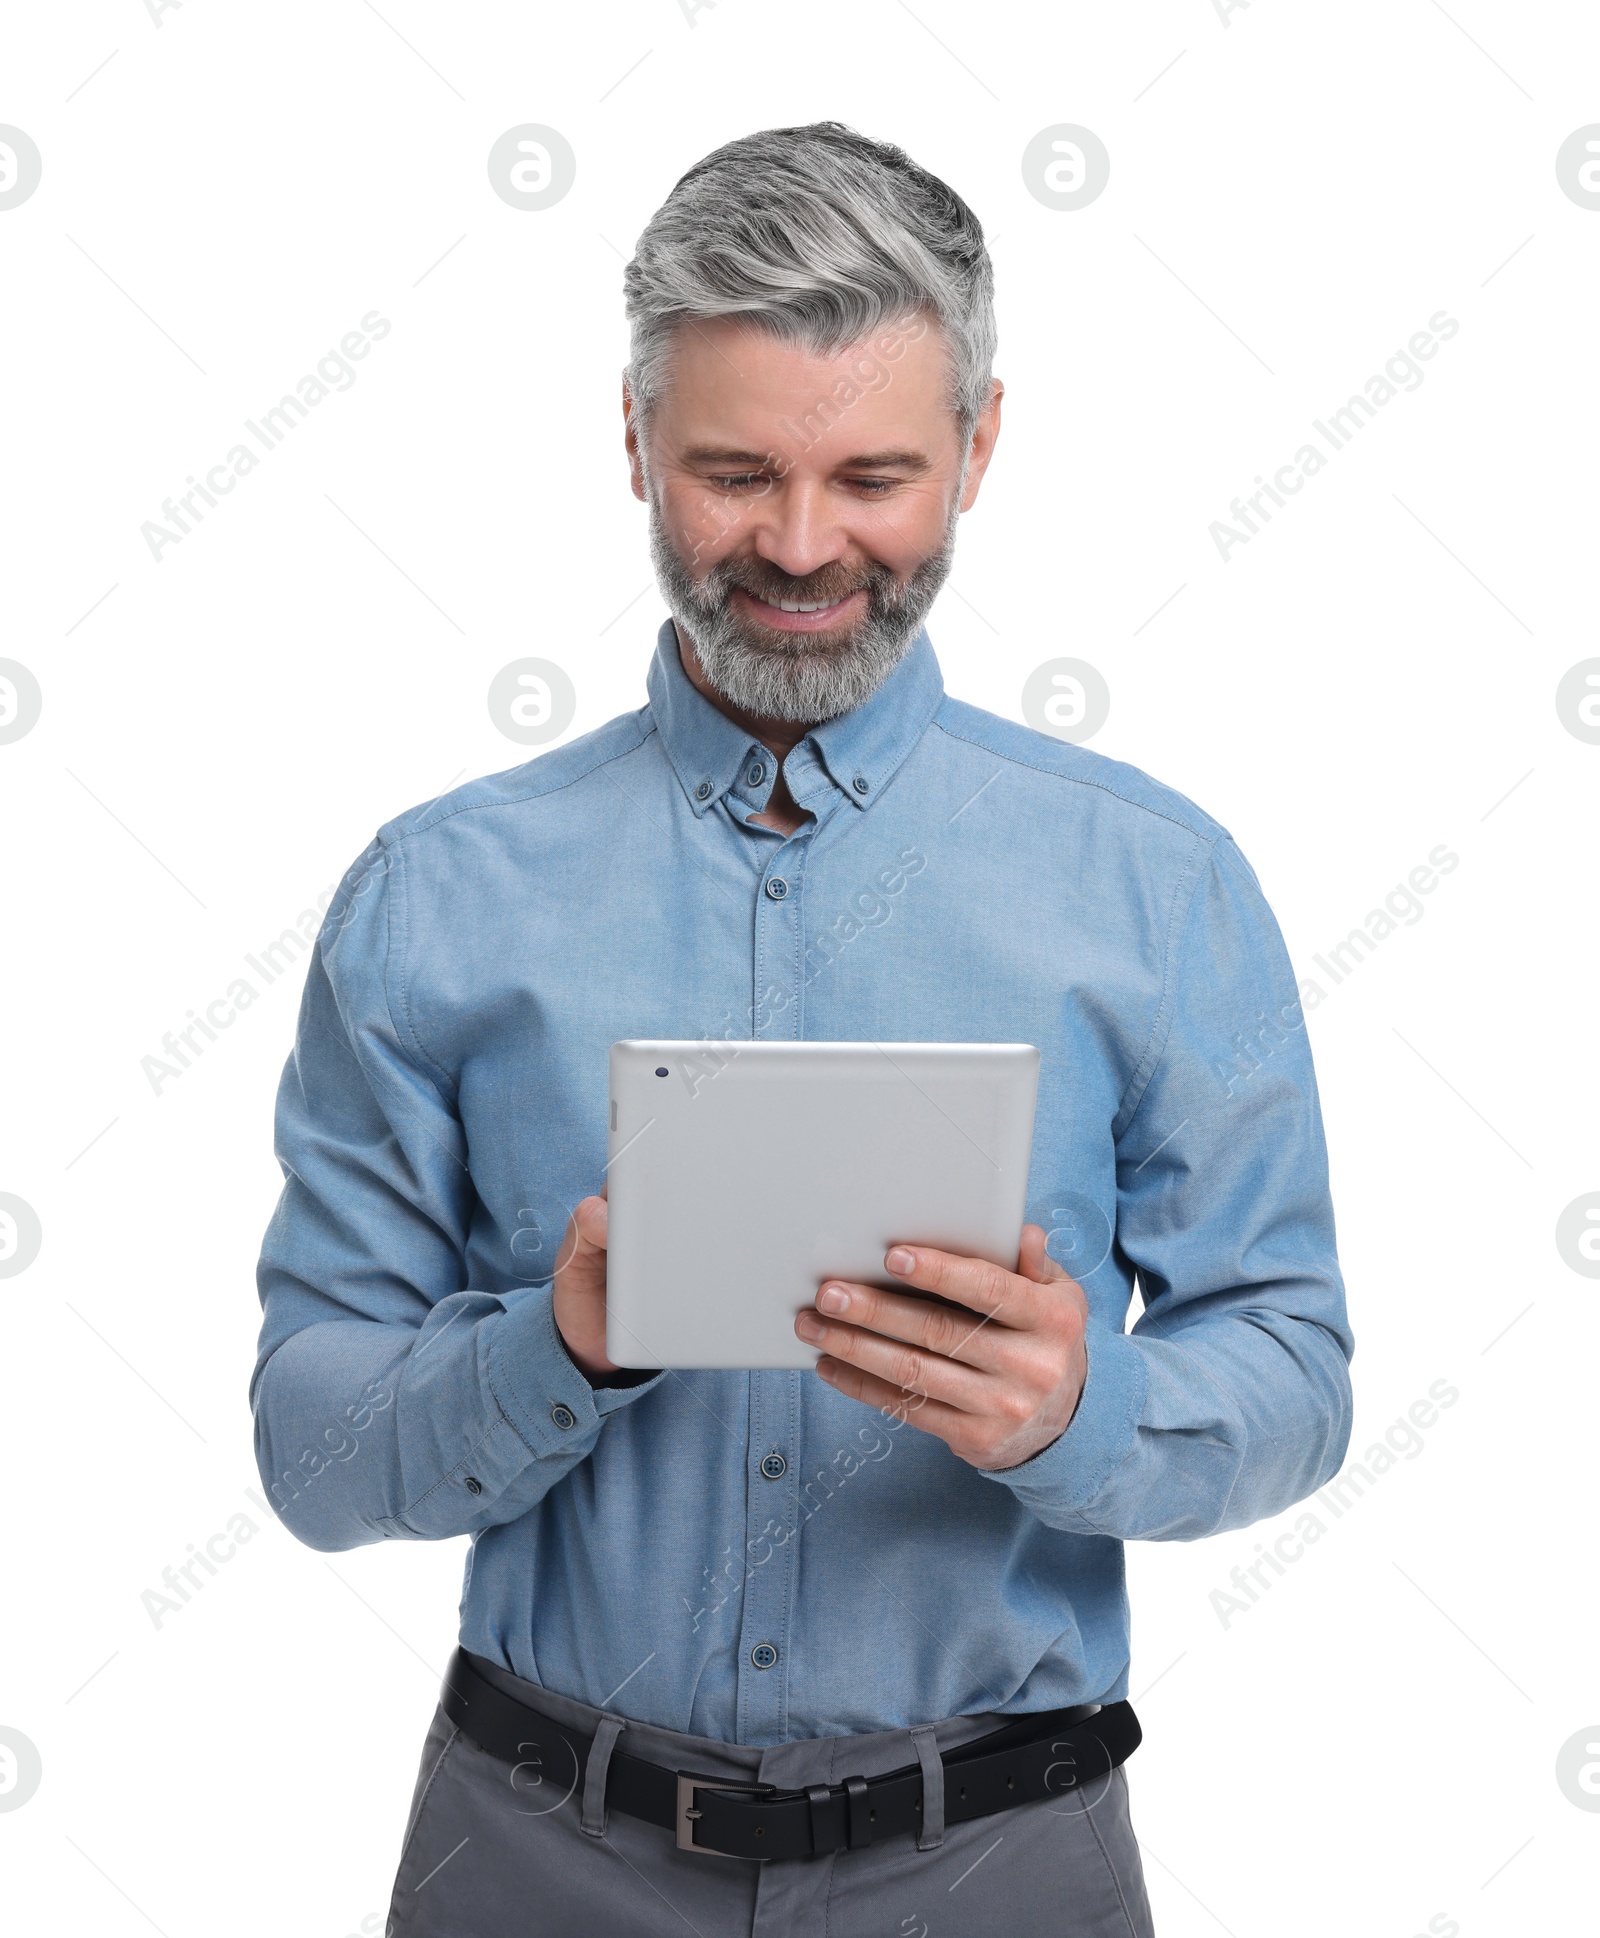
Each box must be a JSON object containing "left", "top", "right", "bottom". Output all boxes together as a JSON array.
[{"left": 622, "top": 122, "right": 996, "bottom": 448}]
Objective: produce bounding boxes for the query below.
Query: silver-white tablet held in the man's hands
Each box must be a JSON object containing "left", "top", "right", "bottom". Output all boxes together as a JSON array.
[{"left": 606, "top": 1041, "right": 1038, "bottom": 1368}]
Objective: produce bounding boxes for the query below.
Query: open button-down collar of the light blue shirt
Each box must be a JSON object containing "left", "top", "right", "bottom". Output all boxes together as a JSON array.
[{"left": 645, "top": 618, "right": 945, "bottom": 814}]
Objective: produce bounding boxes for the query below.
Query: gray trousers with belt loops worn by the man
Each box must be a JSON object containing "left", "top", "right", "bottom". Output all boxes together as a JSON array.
[{"left": 387, "top": 1671, "right": 1153, "bottom": 1938}]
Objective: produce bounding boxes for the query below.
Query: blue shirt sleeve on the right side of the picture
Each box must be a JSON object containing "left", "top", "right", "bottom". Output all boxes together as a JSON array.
[{"left": 992, "top": 835, "right": 1352, "bottom": 1541}]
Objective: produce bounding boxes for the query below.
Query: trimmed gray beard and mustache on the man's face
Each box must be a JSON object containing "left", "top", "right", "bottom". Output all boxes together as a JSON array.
[{"left": 649, "top": 490, "right": 961, "bottom": 727}]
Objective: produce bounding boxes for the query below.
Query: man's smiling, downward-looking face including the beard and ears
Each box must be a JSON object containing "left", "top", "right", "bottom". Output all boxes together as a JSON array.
[{"left": 624, "top": 318, "right": 1000, "bottom": 723}]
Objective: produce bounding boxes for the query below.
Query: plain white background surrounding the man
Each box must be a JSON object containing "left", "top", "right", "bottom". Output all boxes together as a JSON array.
[{"left": 0, "top": 0, "right": 1600, "bottom": 1938}]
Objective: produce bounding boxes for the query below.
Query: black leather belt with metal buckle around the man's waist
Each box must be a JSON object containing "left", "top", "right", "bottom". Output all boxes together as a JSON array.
[{"left": 442, "top": 1649, "right": 1141, "bottom": 1860}]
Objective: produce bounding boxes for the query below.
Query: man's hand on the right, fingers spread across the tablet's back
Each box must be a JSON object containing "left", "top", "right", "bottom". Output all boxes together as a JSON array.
[{"left": 794, "top": 1225, "right": 1089, "bottom": 1469}]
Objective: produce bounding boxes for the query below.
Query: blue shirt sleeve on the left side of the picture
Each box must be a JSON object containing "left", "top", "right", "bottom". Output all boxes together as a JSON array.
[{"left": 250, "top": 837, "right": 655, "bottom": 1550}]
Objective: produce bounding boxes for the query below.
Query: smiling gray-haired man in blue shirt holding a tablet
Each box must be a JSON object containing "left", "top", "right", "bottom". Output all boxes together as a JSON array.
[{"left": 252, "top": 122, "right": 1350, "bottom": 1938}]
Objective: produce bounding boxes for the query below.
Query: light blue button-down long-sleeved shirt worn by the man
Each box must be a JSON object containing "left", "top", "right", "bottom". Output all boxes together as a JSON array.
[{"left": 250, "top": 620, "right": 1352, "bottom": 1744}]
